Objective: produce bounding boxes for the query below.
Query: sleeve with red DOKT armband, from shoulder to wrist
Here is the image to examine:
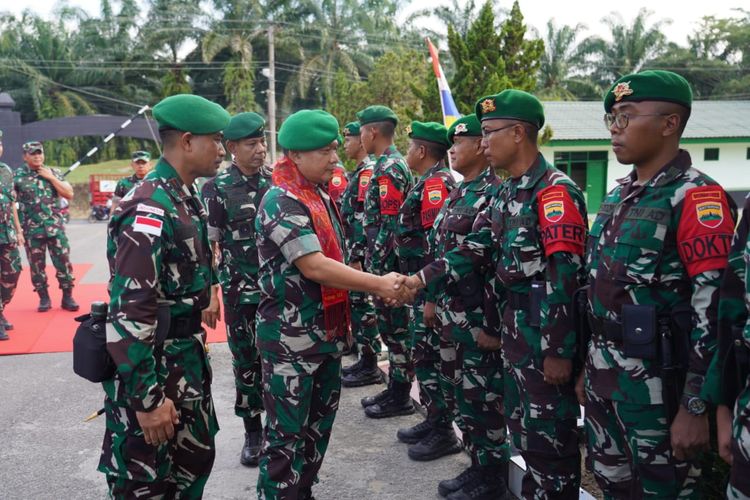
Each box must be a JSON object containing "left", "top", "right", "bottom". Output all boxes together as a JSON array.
[{"left": 677, "top": 186, "right": 736, "bottom": 397}]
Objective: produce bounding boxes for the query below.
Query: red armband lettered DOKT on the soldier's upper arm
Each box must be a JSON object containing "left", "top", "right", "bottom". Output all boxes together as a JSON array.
[{"left": 677, "top": 186, "right": 734, "bottom": 278}]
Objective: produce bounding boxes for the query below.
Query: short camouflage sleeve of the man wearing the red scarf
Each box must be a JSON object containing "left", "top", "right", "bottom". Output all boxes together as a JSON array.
[{"left": 256, "top": 191, "right": 322, "bottom": 264}]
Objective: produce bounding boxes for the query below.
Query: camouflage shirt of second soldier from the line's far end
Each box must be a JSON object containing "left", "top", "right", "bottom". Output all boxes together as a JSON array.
[{"left": 362, "top": 145, "right": 414, "bottom": 274}]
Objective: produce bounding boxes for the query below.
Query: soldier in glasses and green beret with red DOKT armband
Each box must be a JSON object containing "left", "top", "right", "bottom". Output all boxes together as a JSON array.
[{"left": 585, "top": 71, "right": 735, "bottom": 498}]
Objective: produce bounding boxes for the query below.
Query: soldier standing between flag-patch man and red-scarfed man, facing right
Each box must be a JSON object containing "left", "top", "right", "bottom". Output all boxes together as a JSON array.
[{"left": 203, "top": 113, "right": 271, "bottom": 466}]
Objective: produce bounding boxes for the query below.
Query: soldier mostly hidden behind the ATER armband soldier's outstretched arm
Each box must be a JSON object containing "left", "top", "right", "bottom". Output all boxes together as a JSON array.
[{"left": 425, "top": 114, "right": 510, "bottom": 496}]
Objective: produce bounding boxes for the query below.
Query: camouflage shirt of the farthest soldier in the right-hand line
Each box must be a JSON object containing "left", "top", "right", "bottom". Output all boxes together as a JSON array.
[{"left": 341, "top": 156, "right": 375, "bottom": 262}]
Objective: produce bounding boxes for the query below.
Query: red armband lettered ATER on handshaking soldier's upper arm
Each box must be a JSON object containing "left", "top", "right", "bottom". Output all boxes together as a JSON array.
[{"left": 537, "top": 185, "right": 587, "bottom": 257}]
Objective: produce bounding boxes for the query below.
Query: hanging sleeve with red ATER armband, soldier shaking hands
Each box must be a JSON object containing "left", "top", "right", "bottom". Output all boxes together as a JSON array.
[{"left": 537, "top": 185, "right": 587, "bottom": 359}]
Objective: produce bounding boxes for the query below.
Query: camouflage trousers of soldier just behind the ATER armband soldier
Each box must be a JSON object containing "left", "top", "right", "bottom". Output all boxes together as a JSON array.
[{"left": 454, "top": 342, "right": 510, "bottom": 466}]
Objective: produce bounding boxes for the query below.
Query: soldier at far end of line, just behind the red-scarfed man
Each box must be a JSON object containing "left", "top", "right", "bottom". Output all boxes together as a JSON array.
[{"left": 341, "top": 122, "right": 383, "bottom": 387}]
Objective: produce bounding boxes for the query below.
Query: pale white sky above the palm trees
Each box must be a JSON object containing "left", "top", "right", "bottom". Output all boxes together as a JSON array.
[{"left": 0, "top": 0, "right": 750, "bottom": 45}]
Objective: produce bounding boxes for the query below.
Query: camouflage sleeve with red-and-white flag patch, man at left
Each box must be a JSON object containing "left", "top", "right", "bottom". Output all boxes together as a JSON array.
[{"left": 107, "top": 200, "right": 172, "bottom": 412}]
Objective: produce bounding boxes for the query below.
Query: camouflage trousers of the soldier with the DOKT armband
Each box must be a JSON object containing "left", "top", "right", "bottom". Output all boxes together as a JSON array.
[{"left": 586, "top": 390, "right": 701, "bottom": 499}]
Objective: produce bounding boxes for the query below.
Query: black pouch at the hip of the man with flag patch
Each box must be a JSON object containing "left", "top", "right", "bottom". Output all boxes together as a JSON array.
[{"left": 73, "top": 304, "right": 115, "bottom": 383}]
